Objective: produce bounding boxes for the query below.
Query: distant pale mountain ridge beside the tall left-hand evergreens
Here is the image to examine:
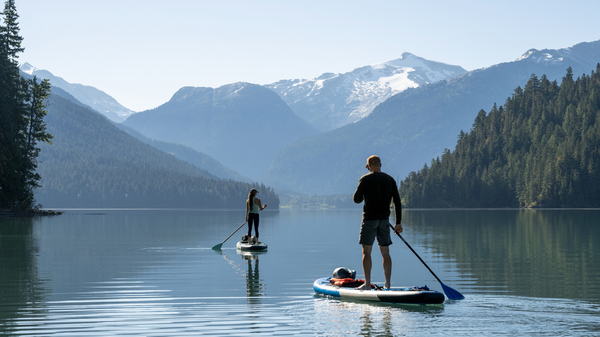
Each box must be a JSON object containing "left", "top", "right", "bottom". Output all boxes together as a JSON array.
[{"left": 20, "top": 63, "right": 134, "bottom": 123}]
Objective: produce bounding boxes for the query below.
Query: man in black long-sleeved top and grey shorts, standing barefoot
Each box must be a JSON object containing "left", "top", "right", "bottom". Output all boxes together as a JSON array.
[{"left": 353, "top": 156, "right": 402, "bottom": 290}]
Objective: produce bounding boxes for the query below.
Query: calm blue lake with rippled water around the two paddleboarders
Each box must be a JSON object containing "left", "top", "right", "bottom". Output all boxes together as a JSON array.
[{"left": 0, "top": 209, "right": 600, "bottom": 336}]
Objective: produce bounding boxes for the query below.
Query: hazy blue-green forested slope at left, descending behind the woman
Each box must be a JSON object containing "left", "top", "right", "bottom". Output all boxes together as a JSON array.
[{"left": 35, "top": 92, "right": 279, "bottom": 209}]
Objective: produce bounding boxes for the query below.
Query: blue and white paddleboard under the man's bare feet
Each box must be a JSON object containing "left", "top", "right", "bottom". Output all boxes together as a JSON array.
[{"left": 313, "top": 277, "right": 445, "bottom": 305}]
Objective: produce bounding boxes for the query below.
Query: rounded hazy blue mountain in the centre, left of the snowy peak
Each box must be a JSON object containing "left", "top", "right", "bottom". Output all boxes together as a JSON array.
[{"left": 123, "top": 83, "right": 317, "bottom": 179}]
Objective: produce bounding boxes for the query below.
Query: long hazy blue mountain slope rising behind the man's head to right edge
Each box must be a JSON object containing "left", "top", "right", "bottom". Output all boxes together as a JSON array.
[{"left": 263, "top": 41, "right": 600, "bottom": 194}]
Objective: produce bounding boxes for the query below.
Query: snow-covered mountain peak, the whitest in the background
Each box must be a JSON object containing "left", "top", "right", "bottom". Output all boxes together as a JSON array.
[{"left": 266, "top": 53, "right": 466, "bottom": 131}]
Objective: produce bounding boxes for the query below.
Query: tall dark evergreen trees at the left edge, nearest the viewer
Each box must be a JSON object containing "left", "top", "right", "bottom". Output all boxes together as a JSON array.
[{"left": 0, "top": 0, "right": 52, "bottom": 210}]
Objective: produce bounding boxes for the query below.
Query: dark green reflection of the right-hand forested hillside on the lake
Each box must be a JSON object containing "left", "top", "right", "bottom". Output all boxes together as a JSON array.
[{"left": 403, "top": 210, "right": 600, "bottom": 301}]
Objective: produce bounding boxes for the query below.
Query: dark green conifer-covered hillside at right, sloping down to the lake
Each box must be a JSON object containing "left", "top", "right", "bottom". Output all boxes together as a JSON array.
[{"left": 400, "top": 64, "right": 600, "bottom": 207}]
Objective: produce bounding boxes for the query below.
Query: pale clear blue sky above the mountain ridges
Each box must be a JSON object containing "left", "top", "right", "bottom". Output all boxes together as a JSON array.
[{"left": 16, "top": 0, "right": 600, "bottom": 111}]
